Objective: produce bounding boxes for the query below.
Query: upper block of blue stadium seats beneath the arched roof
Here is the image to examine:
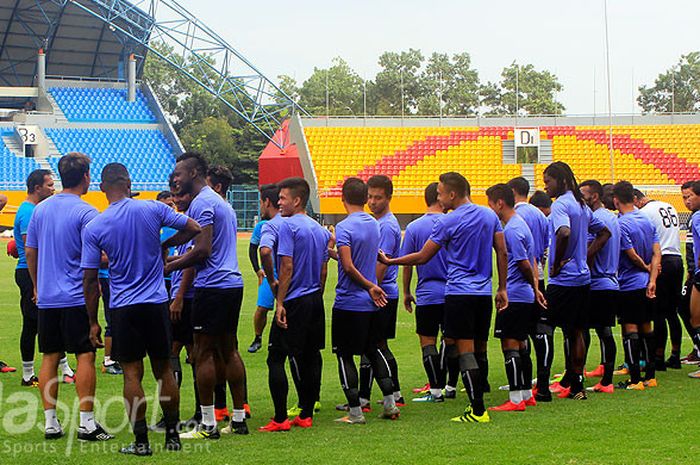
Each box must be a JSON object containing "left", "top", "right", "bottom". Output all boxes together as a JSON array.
[{"left": 49, "top": 87, "right": 157, "bottom": 123}]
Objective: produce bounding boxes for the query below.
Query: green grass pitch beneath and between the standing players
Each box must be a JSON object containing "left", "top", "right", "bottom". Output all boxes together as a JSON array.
[{"left": 0, "top": 239, "right": 700, "bottom": 465}]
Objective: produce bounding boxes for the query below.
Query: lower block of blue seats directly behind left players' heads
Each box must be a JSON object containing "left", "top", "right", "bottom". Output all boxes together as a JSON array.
[{"left": 45, "top": 129, "right": 175, "bottom": 190}]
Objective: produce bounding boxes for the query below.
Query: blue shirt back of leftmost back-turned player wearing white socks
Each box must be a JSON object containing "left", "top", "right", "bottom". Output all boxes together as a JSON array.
[{"left": 25, "top": 193, "right": 97, "bottom": 308}]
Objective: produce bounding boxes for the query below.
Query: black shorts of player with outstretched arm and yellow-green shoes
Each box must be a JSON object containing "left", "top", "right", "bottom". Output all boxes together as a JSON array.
[{"left": 442, "top": 295, "right": 493, "bottom": 341}]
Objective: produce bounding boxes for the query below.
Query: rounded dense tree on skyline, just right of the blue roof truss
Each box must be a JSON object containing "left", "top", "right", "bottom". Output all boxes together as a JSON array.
[{"left": 294, "top": 57, "right": 364, "bottom": 116}]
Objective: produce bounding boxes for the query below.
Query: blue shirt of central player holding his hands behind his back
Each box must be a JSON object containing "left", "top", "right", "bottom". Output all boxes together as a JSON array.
[{"left": 335, "top": 212, "right": 380, "bottom": 311}]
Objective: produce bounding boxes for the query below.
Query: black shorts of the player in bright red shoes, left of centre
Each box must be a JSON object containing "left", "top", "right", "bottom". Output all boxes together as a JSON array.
[{"left": 268, "top": 291, "right": 326, "bottom": 355}]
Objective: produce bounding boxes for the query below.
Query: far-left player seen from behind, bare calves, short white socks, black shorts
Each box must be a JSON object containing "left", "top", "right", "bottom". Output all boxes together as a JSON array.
[{"left": 25, "top": 153, "right": 113, "bottom": 441}]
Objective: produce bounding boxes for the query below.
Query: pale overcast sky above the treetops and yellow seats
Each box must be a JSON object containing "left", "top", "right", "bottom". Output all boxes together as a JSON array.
[{"left": 181, "top": 0, "right": 700, "bottom": 114}]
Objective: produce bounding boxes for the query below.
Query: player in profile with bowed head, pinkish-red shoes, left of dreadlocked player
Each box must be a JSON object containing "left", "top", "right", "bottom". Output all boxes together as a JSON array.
[{"left": 486, "top": 184, "right": 547, "bottom": 412}]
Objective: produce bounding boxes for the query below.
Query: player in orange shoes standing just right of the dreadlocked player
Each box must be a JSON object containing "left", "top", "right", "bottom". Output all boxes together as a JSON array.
[{"left": 579, "top": 180, "right": 620, "bottom": 394}]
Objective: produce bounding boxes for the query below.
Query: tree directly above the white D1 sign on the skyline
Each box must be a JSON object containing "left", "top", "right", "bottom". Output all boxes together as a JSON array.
[{"left": 481, "top": 62, "right": 564, "bottom": 115}]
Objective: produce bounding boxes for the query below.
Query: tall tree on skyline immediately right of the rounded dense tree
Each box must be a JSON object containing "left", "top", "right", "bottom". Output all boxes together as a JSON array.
[{"left": 368, "top": 49, "right": 425, "bottom": 115}]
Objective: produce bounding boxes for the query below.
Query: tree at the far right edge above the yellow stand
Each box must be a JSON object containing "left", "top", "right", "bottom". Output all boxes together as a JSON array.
[{"left": 637, "top": 52, "right": 700, "bottom": 113}]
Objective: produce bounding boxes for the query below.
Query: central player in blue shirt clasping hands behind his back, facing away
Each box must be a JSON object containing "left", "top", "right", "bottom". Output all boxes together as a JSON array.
[{"left": 334, "top": 178, "right": 400, "bottom": 424}]
